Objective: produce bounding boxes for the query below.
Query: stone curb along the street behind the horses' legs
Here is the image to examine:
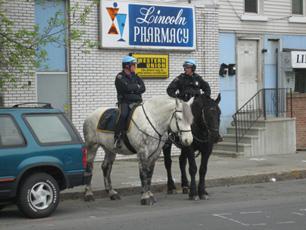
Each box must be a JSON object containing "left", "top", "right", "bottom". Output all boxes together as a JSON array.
[{"left": 60, "top": 169, "right": 306, "bottom": 201}]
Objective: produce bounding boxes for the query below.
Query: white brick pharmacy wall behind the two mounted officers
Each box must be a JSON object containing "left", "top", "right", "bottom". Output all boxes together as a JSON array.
[{"left": 70, "top": 1, "right": 219, "bottom": 159}]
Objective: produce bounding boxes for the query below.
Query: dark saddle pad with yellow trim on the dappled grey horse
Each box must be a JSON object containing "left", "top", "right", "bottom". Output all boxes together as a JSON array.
[{"left": 97, "top": 106, "right": 137, "bottom": 133}]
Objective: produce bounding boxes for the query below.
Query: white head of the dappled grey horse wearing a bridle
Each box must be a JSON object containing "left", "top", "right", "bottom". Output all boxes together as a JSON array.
[{"left": 170, "top": 99, "right": 193, "bottom": 146}]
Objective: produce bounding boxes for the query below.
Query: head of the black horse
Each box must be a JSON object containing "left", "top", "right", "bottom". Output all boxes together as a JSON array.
[{"left": 191, "top": 94, "right": 222, "bottom": 144}]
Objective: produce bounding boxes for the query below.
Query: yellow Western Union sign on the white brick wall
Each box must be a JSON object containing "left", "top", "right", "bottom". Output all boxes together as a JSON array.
[{"left": 133, "top": 54, "right": 169, "bottom": 78}]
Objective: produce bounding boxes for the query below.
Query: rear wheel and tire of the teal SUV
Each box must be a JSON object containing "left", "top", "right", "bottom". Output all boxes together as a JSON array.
[{"left": 16, "top": 173, "right": 60, "bottom": 218}]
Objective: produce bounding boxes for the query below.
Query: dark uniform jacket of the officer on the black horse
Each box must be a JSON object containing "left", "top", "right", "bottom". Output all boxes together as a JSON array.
[{"left": 167, "top": 73, "right": 210, "bottom": 101}]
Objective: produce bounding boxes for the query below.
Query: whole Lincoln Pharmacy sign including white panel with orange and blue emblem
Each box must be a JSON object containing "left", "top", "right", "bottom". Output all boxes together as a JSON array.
[{"left": 100, "top": 1, "right": 196, "bottom": 50}]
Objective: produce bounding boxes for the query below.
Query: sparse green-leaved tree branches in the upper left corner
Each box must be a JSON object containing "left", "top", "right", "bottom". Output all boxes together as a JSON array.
[{"left": 0, "top": 0, "right": 99, "bottom": 91}]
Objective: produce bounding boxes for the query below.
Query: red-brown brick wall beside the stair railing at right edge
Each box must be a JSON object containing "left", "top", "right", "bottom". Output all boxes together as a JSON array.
[{"left": 287, "top": 94, "right": 306, "bottom": 150}]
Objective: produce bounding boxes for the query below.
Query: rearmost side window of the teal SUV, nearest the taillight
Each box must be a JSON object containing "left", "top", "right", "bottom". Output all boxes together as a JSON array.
[{"left": 25, "top": 114, "right": 77, "bottom": 145}]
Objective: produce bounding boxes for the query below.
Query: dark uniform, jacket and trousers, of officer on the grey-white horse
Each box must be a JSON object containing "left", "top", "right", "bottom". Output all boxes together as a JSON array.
[{"left": 115, "top": 71, "right": 146, "bottom": 136}]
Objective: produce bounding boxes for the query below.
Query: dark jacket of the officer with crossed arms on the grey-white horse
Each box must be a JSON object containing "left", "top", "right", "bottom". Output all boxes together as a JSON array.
[{"left": 115, "top": 71, "right": 146, "bottom": 104}]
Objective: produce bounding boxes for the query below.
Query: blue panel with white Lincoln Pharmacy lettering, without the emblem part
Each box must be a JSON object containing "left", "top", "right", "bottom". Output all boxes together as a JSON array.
[{"left": 128, "top": 4, "right": 195, "bottom": 48}]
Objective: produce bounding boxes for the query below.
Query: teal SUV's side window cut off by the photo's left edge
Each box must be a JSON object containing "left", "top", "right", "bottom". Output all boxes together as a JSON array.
[{"left": 0, "top": 115, "right": 25, "bottom": 148}]
